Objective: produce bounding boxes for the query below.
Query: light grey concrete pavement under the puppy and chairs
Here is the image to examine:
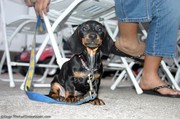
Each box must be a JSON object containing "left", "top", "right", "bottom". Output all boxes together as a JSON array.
[{"left": 0, "top": 74, "right": 180, "bottom": 119}]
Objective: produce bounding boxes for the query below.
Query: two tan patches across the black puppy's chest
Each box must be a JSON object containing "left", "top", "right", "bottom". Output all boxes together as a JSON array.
[{"left": 74, "top": 71, "right": 101, "bottom": 79}]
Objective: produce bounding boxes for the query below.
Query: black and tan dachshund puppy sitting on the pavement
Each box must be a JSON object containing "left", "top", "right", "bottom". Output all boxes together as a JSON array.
[{"left": 49, "top": 20, "right": 113, "bottom": 105}]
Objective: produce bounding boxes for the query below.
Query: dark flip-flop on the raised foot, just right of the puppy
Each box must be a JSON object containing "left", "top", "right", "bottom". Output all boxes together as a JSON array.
[{"left": 111, "top": 43, "right": 144, "bottom": 63}]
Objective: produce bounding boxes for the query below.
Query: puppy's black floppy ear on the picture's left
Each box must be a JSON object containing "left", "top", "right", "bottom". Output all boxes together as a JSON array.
[{"left": 67, "top": 25, "right": 84, "bottom": 54}]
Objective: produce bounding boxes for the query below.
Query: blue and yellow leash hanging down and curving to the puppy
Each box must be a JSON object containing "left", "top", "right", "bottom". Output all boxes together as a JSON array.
[{"left": 24, "top": 16, "right": 97, "bottom": 105}]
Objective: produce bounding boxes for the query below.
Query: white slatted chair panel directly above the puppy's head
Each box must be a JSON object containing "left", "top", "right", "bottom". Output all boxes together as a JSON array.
[{"left": 48, "top": 0, "right": 115, "bottom": 25}]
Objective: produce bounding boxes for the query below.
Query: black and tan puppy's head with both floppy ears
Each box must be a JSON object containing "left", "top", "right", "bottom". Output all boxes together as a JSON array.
[{"left": 67, "top": 20, "right": 113, "bottom": 55}]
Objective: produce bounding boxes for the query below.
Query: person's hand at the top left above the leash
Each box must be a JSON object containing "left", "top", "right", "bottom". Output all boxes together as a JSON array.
[{"left": 24, "top": 0, "right": 50, "bottom": 18}]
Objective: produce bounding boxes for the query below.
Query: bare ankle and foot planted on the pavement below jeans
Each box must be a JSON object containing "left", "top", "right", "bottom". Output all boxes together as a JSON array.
[{"left": 140, "top": 55, "right": 180, "bottom": 95}]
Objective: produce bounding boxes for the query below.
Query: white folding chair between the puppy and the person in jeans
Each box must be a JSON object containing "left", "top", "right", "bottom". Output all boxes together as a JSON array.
[{"left": 105, "top": 21, "right": 142, "bottom": 94}]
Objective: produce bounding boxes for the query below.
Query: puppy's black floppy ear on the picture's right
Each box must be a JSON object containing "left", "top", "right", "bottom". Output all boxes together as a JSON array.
[{"left": 101, "top": 31, "right": 114, "bottom": 55}]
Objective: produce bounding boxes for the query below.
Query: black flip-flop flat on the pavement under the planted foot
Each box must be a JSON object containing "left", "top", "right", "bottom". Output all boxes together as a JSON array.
[{"left": 143, "top": 85, "right": 180, "bottom": 98}]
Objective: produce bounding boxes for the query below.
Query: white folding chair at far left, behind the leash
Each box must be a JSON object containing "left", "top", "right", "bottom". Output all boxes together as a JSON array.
[{"left": 0, "top": 1, "right": 64, "bottom": 87}]
